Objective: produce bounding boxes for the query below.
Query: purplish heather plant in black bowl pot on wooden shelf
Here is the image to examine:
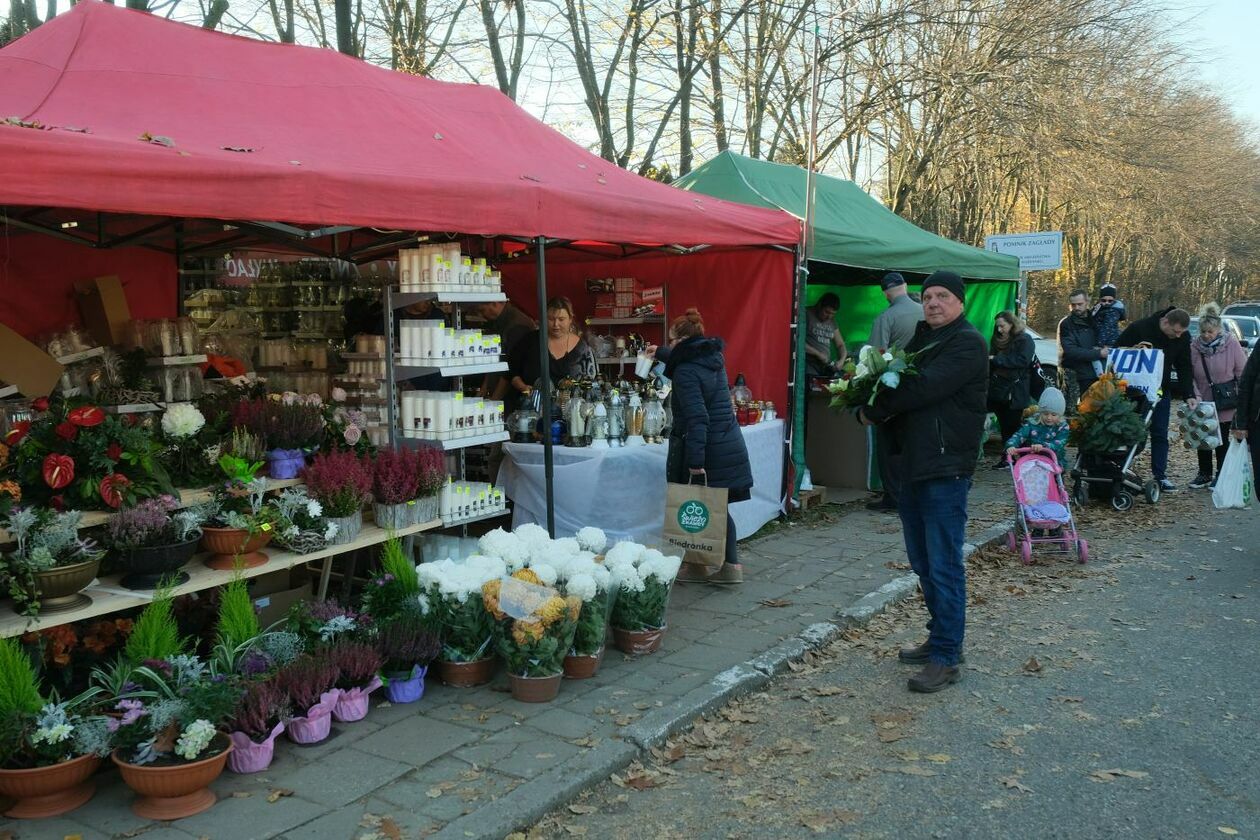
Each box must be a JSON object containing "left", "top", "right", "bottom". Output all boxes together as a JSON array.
[{"left": 105, "top": 496, "right": 205, "bottom": 589}]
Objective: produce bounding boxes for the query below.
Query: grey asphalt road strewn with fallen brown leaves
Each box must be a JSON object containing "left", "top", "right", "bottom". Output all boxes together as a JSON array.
[{"left": 522, "top": 465, "right": 1260, "bottom": 839}]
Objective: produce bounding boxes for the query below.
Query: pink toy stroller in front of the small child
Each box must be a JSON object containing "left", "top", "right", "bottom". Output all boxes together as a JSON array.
[{"left": 1007, "top": 448, "right": 1090, "bottom": 564}]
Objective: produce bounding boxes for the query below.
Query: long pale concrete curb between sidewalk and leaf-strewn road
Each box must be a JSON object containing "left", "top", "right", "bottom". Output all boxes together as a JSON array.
[{"left": 433, "top": 520, "right": 1014, "bottom": 840}]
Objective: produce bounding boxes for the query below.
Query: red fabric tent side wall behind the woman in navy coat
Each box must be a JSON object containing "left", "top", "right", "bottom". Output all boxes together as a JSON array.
[{"left": 503, "top": 248, "right": 794, "bottom": 416}]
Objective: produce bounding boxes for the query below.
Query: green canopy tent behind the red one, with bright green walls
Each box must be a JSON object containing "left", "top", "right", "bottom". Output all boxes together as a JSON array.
[{"left": 674, "top": 151, "right": 1019, "bottom": 496}]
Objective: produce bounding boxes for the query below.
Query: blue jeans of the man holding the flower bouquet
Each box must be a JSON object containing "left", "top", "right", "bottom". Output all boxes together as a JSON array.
[{"left": 897, "top": 476, "right": 971, "bottom": 665}]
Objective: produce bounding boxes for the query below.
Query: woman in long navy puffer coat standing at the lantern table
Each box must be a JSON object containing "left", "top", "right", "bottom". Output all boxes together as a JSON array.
[{"left": 656, "top": 309, "right": 752, "bottom": 583}]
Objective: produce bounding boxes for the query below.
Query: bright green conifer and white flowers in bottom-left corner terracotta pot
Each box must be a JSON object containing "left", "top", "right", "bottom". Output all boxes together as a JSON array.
[{"left": 0, "top": 639, "right": 111, "bottom": 820}]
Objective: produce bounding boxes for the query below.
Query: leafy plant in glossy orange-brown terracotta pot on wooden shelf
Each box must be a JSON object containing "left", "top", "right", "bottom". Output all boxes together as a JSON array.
[{"left": 202, "top": 455, "right": 278, "bottom": 570}]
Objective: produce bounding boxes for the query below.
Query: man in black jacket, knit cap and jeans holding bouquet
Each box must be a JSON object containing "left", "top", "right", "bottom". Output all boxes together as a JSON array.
[{"left": 858, "top": 271, "right": 989, "bottom": 691}]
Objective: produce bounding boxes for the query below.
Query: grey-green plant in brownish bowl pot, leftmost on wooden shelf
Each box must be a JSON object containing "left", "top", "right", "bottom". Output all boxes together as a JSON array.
[{"left": 0, "top": 508, "right": 105, "bottom": 617}]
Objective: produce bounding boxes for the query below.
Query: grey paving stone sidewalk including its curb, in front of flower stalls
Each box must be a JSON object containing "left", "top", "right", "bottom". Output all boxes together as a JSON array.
[{"left": 0, "top": 471, "right": 1011, "bottom": 840}]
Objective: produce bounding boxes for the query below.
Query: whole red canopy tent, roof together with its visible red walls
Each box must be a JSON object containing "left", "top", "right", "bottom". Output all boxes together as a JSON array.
[{"left": 0, "top": 0, "right": 800, "bottom": 531}]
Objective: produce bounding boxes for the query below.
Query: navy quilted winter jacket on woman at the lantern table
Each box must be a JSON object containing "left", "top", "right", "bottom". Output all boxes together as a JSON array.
[{"left": 656, "top": 336, "right": 752, "bottom": 490}]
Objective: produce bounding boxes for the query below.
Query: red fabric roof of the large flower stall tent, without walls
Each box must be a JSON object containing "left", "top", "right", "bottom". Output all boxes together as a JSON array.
[{"left": 0, "top": 0, "right": 799, "bottom": 246}]
